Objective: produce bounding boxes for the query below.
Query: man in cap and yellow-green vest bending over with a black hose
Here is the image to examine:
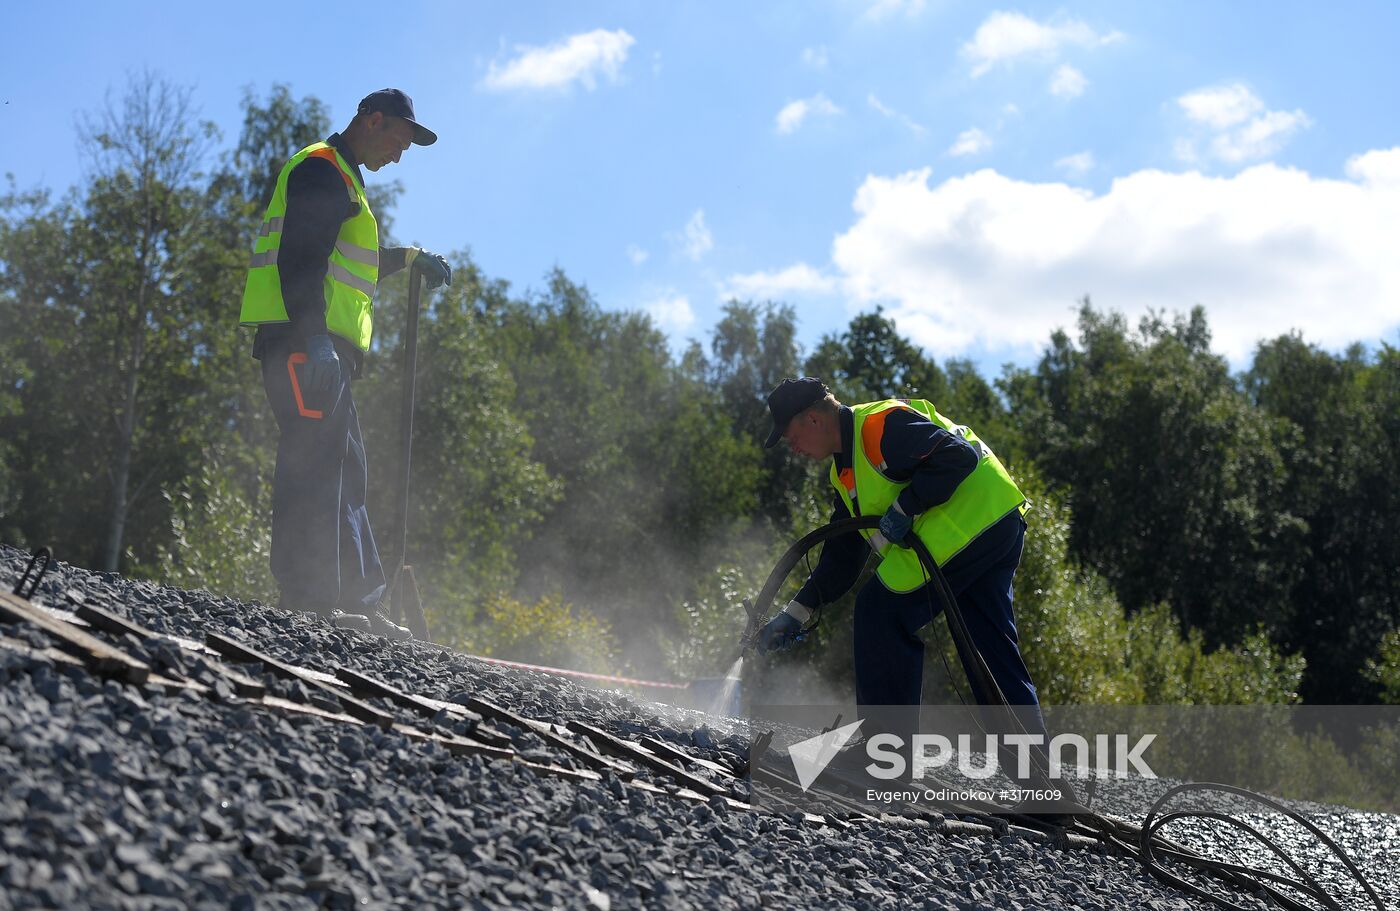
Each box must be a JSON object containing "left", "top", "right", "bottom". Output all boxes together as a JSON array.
[{"left": 759, "top": 376, "right": 1044, "bottom": 735}]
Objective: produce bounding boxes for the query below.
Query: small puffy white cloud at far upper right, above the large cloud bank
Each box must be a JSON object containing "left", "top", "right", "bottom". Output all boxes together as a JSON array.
[{"left": 1175, "top": 83, "right": 1312, "bottom": 164}]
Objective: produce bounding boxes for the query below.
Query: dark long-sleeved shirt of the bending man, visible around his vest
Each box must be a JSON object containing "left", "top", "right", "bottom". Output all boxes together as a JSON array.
[{"left": 794, "top": 404, "right": 977, "bottom": 607}]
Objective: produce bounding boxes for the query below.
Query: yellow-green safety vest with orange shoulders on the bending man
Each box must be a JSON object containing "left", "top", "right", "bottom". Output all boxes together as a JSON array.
[{"left": 830, "top": 399, "right": 1026, "bottom": 592}]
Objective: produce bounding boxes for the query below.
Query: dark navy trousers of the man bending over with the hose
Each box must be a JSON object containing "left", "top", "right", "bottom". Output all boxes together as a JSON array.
[{"left": 855, "top": 514, "right": 1044, "bottom": 735}]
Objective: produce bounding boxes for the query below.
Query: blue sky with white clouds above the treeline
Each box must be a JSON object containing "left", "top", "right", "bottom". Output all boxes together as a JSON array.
[{"left": 0, "top": 0, "right": 1400, "bottom": 375}]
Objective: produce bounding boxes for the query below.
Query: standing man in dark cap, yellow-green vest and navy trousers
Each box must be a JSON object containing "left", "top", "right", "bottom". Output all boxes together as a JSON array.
[{"left": 239, "top": 88, "right": 452, "bottom": 638}]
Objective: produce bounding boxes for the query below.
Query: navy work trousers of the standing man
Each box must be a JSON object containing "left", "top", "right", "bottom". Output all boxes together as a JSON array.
[{"left": 262, "top": 346, "right": 385, "bottom": 613}]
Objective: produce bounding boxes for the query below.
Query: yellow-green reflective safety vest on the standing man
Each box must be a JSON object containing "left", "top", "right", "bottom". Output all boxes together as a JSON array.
[{"left": 238, "top": 143, "right": 379, "bottom": 351}]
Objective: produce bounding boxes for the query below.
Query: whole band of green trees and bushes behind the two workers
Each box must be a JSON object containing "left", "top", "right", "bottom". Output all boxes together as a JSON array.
[{"left": 0, "top": 73, "right": 1400, "bottom": 702}]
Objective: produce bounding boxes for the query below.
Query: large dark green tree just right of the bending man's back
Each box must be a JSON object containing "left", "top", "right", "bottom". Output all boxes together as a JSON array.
[{"left": 1004, "top": 302, "right": 1305, "bottom": 644}]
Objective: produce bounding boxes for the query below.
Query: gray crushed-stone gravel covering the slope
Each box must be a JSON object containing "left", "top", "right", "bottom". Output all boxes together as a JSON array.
[{"left": 0, "top": 547, "right": 1400, "bottom": 911}]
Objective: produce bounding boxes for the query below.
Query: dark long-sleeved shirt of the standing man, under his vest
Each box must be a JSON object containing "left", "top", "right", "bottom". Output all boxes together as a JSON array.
[{"left": 253, "top": 133, "right": 406, "bottom": 376}]
